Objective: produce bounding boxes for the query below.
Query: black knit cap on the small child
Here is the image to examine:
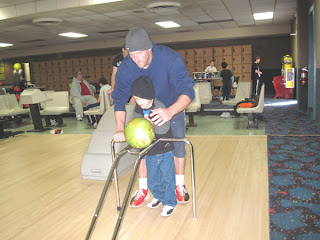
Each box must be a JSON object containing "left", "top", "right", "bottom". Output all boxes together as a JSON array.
[{"left": 130, "top": 76, "right": 155, "bottom": 99}]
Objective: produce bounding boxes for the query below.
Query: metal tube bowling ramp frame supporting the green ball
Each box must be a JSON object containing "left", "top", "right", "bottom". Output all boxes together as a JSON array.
[{"left": 85, "top": 138, "right": 196, "bottom": 240}]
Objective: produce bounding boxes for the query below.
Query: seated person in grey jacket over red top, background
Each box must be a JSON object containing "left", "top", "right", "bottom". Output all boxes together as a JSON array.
[{"left": 70, "top": 72, "right": 97, "bottom": 121}]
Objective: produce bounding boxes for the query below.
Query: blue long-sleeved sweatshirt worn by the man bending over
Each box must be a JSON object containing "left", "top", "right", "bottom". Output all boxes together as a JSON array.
[{"left": 112, "top": 42, "right": 194, "bottom": 111}]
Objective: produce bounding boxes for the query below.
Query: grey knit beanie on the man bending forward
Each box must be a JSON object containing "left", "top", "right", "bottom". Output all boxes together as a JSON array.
[{"left": 126, "top": 27, "right": 152, "bottom": 53}]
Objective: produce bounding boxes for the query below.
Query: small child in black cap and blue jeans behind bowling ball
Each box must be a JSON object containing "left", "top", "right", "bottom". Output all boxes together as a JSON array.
[{"left": 130, "top": 76, "right": 177, "bottom": 216}]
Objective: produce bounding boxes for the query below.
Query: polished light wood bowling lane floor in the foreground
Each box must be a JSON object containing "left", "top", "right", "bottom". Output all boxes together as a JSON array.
[{"left": 0, "top": 135, "right": 269, "bottom": 240}]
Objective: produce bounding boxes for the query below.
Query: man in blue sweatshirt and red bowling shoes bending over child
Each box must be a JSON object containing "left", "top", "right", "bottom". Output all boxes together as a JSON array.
[{"left": 112, "top": 27, "right": 194, "bottom": 207}]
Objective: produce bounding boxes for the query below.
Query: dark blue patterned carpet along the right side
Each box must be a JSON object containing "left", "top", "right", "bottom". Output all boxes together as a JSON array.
[{"left": 263, "top": 102, "right": 320, "bottom": 240}]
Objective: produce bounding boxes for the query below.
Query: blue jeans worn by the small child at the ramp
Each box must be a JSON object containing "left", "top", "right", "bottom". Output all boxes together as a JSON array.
[{"left": 145, "top": 151, "right": 177, "bottom": 207}]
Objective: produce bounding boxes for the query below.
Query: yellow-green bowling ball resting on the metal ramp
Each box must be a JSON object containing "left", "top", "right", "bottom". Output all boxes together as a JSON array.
[{"left": 124, "top": 118, "right": 155, "bottom": 149}]
